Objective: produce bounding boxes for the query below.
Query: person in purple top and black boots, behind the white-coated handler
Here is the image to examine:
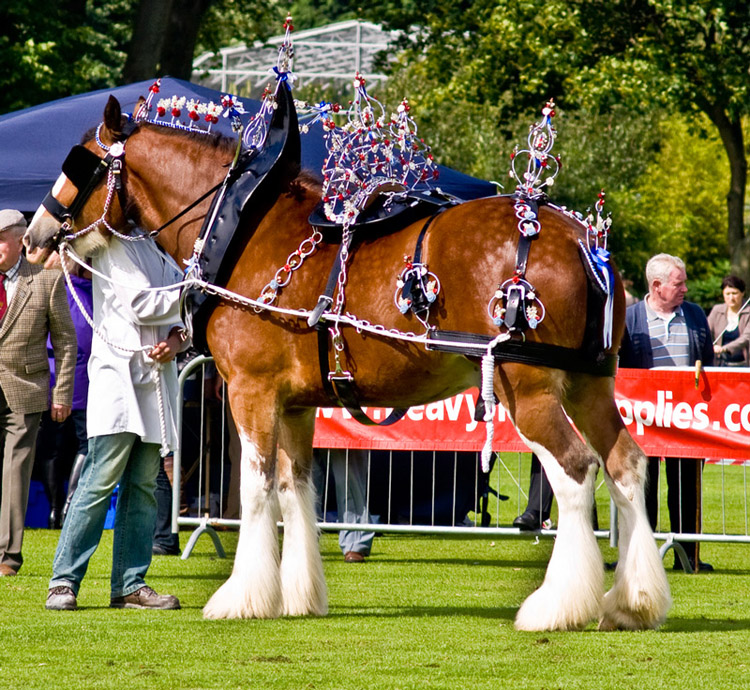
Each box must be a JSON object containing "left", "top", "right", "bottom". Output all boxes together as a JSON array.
[{"left": 35, "top": 272, "right": 92, "bottom": 528}]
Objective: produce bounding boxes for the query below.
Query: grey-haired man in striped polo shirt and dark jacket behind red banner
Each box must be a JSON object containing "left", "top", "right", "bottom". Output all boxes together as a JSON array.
[{"left": 620, "top": 254, "right": 713, "bottom": 570}]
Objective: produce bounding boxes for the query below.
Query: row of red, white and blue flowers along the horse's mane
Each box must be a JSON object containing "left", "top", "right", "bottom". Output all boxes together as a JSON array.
[{"left": 133, "top": 79, "right": 245, "bottom": 134}]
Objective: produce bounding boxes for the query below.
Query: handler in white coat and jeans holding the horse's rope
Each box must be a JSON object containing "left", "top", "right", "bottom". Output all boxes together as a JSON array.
[{"left": 47, "top": 231, "right": 188, "bottom": 610}]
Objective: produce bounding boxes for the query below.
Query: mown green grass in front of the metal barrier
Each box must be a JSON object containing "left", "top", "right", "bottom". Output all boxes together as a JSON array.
[{"left": 0, "top": 530, "right": 750, "bottom": 690}]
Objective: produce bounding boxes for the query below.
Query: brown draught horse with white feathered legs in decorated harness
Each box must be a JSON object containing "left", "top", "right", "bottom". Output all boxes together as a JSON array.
[{"left": 26, "top": 99, "right": 671, "bottom": 630}]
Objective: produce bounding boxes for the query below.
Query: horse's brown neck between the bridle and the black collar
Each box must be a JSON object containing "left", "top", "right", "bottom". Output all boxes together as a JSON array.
[{"left": 127, "top": 128, "right": 232, "bottom": 264}]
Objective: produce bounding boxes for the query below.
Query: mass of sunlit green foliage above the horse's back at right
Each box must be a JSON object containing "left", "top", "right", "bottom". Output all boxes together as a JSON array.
[{"left": 367, "top": 0, "right": 750, "bottom": 284}]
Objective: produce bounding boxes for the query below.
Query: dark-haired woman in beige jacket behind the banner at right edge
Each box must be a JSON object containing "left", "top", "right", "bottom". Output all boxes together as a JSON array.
[{"left": 708, "top": 275, "right": 750, "bottom": 367}]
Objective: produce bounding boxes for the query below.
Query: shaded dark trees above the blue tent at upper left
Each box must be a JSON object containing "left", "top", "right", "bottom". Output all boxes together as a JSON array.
[{"left": 0, "top": 0, "right": 356, "bottom": 113}]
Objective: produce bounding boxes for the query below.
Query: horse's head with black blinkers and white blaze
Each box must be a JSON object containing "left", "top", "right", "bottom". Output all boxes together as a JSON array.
[{"left": 24, "top": 96, "right": 135, "bottom": 263}]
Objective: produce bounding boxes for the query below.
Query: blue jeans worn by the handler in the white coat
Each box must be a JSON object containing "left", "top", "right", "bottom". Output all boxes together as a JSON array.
[{"left": 50, "top": 432, "right": 159, "bottom": 597}]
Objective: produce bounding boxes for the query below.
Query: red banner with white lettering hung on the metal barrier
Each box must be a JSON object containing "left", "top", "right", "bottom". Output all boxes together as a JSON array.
[{"left": 315, "top": 367, "right": 750, "bottom": 460}]
